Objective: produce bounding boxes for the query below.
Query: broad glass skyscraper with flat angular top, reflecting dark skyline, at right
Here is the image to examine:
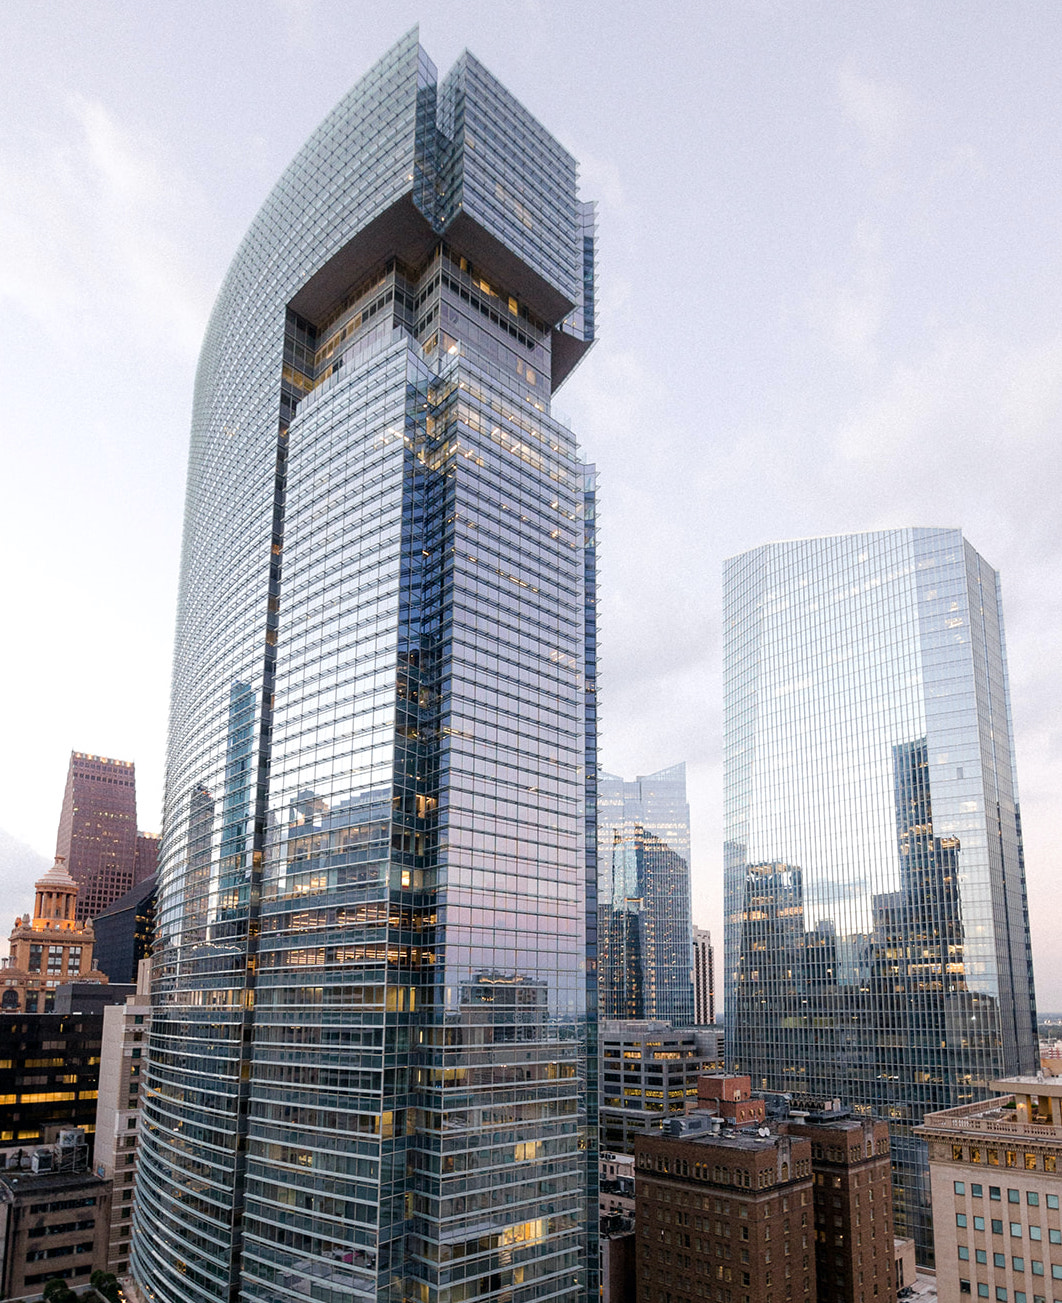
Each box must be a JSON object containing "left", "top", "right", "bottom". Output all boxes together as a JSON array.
[{"left": 725, "top": 529, "right": 1037, "bottom": 1260}]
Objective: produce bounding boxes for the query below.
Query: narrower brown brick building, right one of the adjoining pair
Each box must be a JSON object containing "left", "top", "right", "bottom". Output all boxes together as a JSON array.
[{"left": 784, "top": 1118, "right": 897, "bottom": 1303}]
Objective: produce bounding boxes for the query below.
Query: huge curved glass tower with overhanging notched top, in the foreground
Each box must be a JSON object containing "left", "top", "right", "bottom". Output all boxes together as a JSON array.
[{"left": 132, "top": 31, "right": 597, "bottom": 1303}]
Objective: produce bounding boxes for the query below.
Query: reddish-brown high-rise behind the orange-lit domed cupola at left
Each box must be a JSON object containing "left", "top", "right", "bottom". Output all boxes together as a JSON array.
[{"left": 55, "top": 751, "right": 137, "bottom": 919}]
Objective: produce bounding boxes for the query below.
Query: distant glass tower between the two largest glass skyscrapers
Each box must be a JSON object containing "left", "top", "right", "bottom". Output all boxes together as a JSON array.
[{"left": 597, "top": 765, "right": 693, "bottom": 1027}]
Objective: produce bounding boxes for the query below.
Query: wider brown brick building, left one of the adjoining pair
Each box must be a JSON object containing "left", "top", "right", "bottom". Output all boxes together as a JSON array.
[{"left": 635, "top": 1134, "right": 816, "bottom": 1303}]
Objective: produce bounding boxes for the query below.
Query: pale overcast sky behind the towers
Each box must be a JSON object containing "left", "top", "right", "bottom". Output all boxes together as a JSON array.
[{"left": 0, "top": 0, "right": 1062, "bottom": 1010}]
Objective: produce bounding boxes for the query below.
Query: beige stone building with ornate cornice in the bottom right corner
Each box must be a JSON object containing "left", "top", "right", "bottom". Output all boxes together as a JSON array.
[{"left": 919, "top": 1078, "right": 1062, "bottom": 1303}]
